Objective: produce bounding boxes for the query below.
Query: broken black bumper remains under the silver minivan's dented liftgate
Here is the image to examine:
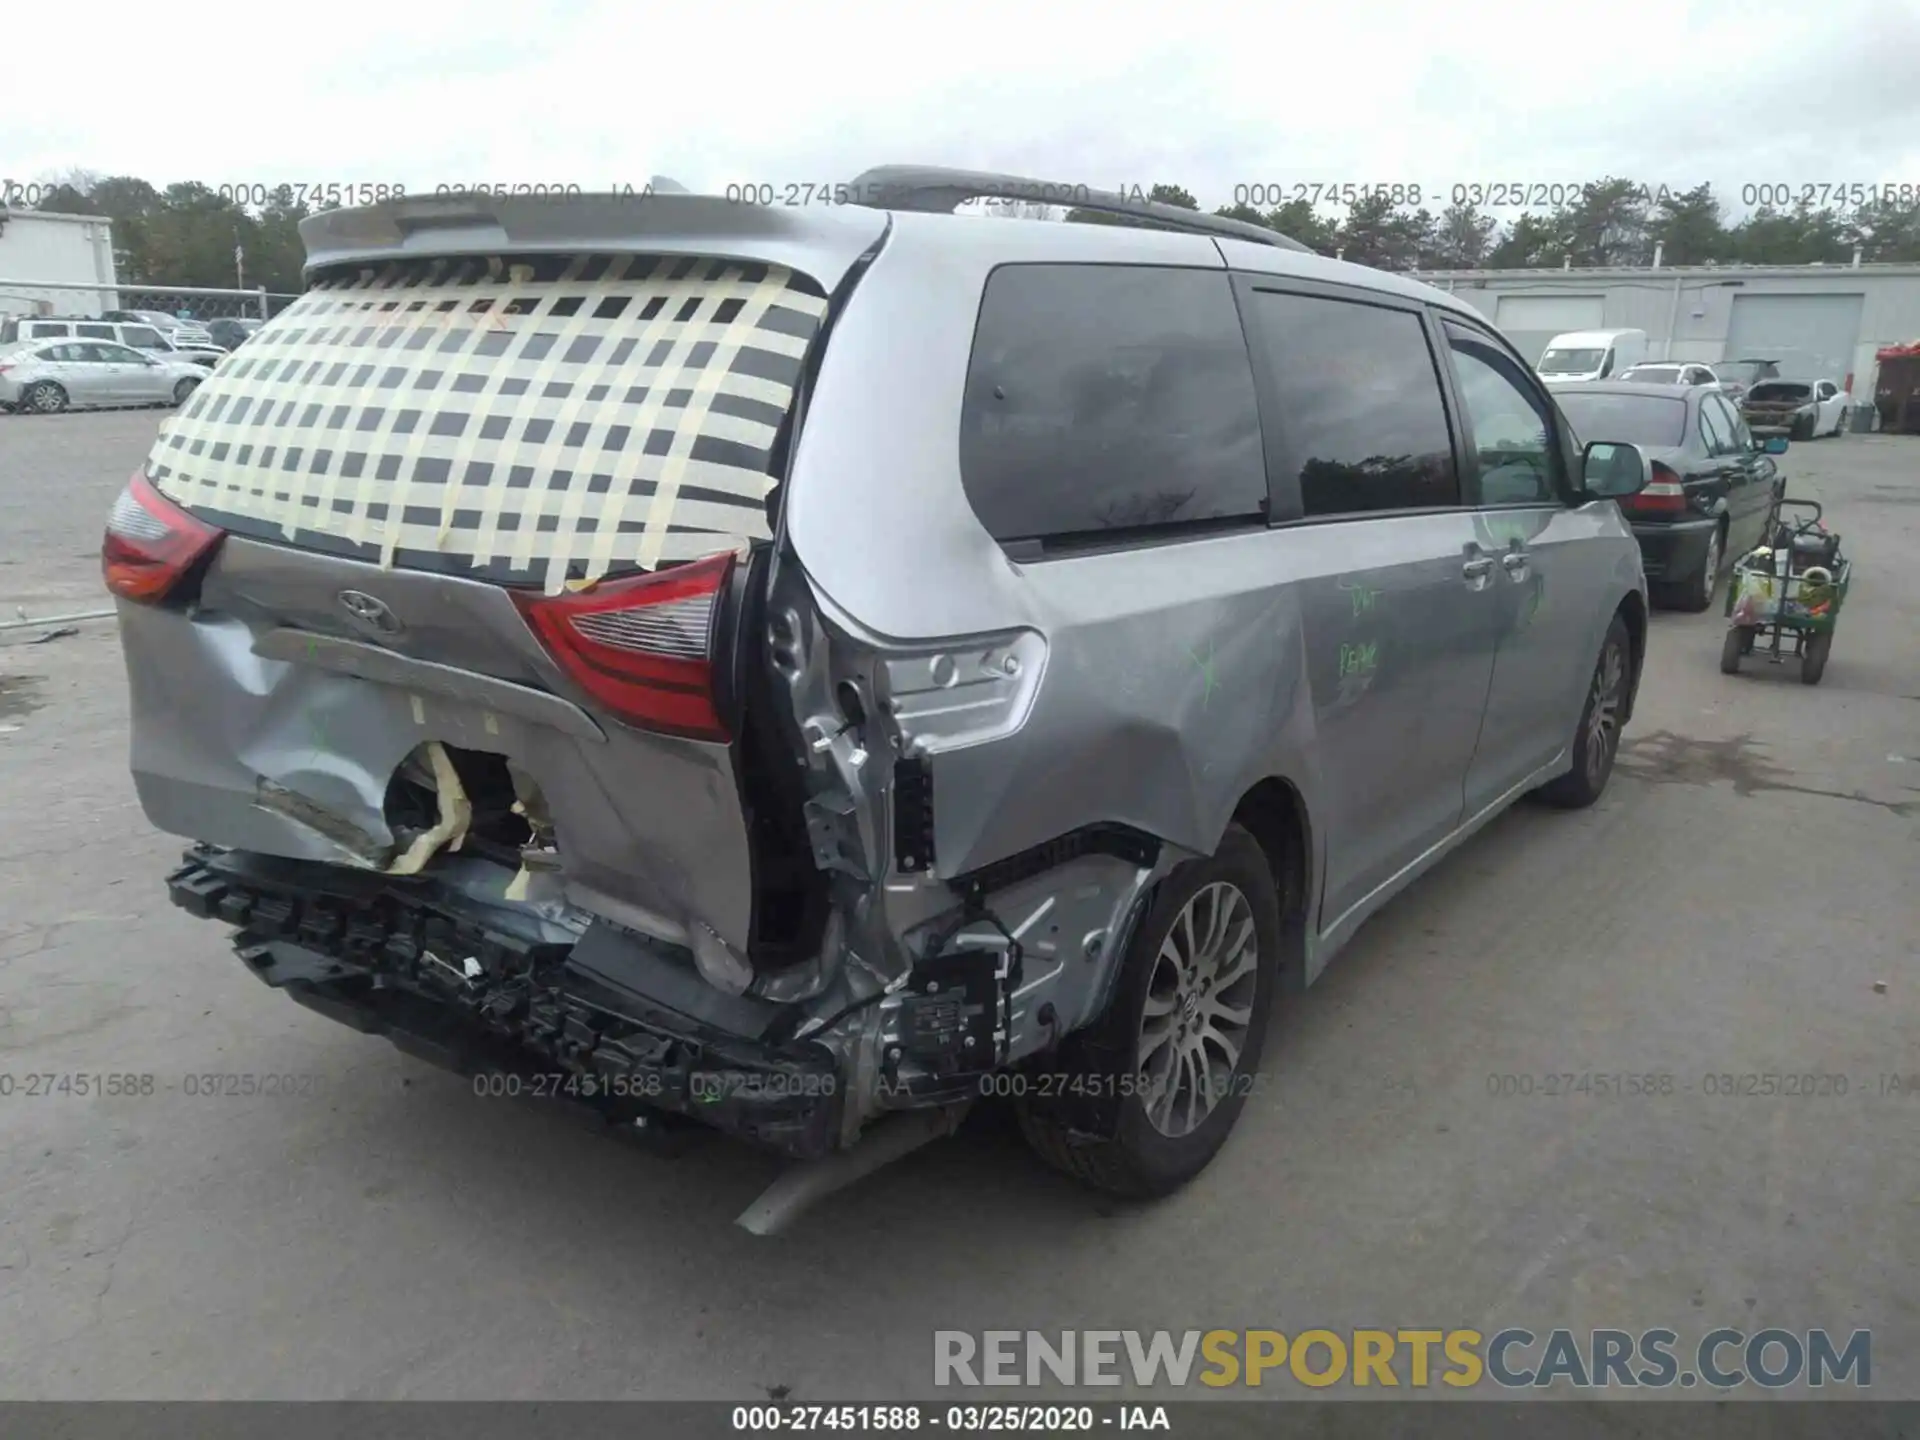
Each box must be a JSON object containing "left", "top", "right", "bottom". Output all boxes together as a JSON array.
[{"left": 167, "top": 845, "right": 843, "bottom": 1160}]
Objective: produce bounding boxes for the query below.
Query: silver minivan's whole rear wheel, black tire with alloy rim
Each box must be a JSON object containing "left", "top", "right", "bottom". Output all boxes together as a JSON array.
[{"left": 1014, "top": 826, "right": 1283, "bottom": 1200}]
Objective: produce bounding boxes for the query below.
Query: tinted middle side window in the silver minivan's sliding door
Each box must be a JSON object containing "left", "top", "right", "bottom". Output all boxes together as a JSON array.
[{"left": 1248, "top": 290, "right": 1459, "bottom": 515}]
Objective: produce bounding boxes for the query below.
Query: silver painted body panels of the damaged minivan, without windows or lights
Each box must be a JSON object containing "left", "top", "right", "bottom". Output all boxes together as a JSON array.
[{"left": 121, "top": 198, "right": 1644, "bottom": 1142}]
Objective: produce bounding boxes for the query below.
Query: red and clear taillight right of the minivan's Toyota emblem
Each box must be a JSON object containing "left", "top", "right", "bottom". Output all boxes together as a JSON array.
[{"left": 515, "top": 553, "right": 733, "bottom": 741}]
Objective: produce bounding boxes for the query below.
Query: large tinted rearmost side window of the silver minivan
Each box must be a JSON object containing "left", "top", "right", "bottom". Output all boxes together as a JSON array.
[{"left": 960, "top": 265, "right": 1267, "bottom": 541}]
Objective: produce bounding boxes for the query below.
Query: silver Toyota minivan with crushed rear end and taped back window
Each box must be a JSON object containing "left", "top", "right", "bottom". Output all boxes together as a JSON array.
[{"left": 104, "top": 167, "right": 1647, "bottom": 1221}]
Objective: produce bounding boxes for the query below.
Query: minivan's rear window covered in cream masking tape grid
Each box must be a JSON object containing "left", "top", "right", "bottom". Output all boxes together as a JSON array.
[{"left": 148, "top": 255, "right": 828, "bottom": 593}]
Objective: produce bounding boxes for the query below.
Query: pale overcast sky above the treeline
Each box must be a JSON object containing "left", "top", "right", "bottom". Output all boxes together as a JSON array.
[{"left": 11, "top": 0, "right": 1920, "bottom": 211}]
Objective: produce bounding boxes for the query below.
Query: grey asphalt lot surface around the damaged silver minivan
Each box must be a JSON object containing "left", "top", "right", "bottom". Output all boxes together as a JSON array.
[{"left": 0, "top": 411, "right": 1920, "bottom": 1400}]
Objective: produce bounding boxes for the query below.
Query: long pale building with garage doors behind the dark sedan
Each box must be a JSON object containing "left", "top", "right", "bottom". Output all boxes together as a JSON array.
[{"left": 1419, "top": 265, "right": 1920, "bottom": 399}]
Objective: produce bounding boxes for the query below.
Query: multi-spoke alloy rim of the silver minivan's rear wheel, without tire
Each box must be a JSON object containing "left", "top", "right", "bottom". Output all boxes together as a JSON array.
[{"left": 1137, "top": 881, "right": 1260, "bottom": 1139}]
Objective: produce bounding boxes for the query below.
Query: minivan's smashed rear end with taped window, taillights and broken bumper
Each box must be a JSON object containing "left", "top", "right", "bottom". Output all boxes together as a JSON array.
[{"left": 104, "top": 196, "right": 885, "bottom": 1152}]
